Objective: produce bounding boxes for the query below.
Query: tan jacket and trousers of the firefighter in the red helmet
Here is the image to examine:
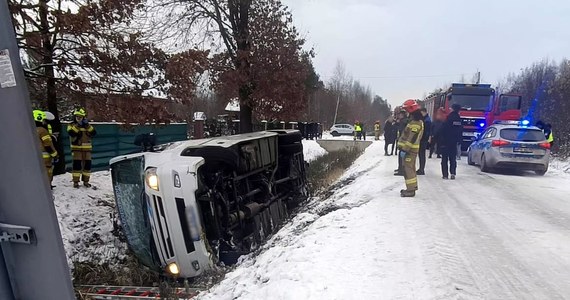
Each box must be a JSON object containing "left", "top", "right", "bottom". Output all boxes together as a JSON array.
[{"left": 398, "top": 120, "right": 424, "bottom": 191}]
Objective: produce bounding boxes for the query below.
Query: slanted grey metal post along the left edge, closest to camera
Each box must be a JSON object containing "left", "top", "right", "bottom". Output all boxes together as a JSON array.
[{"left": 0, "top": 0, "right": 75, "bottom": 300}]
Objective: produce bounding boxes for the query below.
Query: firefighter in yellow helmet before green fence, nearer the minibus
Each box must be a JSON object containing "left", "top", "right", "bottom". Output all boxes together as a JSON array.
[{"left": 67, "top": 108, "right": 97, "bottom": 188}]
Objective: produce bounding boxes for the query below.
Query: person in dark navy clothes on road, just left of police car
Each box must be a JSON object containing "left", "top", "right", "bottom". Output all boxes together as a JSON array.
[{"left": 437, "top": 103, "right": 463, "bottom": 179}]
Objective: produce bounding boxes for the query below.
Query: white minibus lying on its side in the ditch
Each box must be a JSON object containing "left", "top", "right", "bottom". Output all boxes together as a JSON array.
[{"left": 110, "top": 130, "right": 308, "bottom": 278}]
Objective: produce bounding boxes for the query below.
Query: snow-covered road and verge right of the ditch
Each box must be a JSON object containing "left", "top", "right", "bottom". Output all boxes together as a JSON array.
[{"left": 202, "top": 142, "right": 570, "bottom": 299}]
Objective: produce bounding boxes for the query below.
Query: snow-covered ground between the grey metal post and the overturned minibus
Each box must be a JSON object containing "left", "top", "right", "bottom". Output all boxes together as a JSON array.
[{"left": 53, "top": 171, "right": 127, "bottom": 267}]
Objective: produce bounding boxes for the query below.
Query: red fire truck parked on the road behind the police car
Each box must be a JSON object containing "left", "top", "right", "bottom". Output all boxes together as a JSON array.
[{"left": 423, "top": 83, "right": 522, "bottom": 151}]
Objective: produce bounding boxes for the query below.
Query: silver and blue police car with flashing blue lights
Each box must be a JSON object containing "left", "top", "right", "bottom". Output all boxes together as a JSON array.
[{"left": 467, "top": 121, "right": 550, "bottom": 175}]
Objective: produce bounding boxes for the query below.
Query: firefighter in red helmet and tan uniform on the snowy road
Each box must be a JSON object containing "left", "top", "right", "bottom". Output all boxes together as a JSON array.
[{"left": 398, "top": 99, "right": 424, "bottom": 197}]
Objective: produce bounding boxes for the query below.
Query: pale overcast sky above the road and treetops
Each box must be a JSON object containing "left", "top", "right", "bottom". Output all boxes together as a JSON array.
[{"left": 282, "top": 0, "right": 570, "bottom": 104}]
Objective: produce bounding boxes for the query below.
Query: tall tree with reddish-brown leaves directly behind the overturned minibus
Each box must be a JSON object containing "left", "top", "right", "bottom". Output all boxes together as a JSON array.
[{"left": 147, "top": 0, "right": 308, "bottom": 132}]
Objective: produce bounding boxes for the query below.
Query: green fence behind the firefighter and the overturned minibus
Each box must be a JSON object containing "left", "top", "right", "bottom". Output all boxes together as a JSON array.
[{"left": 60, "top": 122, "right": 188, "bottom": 171}]
